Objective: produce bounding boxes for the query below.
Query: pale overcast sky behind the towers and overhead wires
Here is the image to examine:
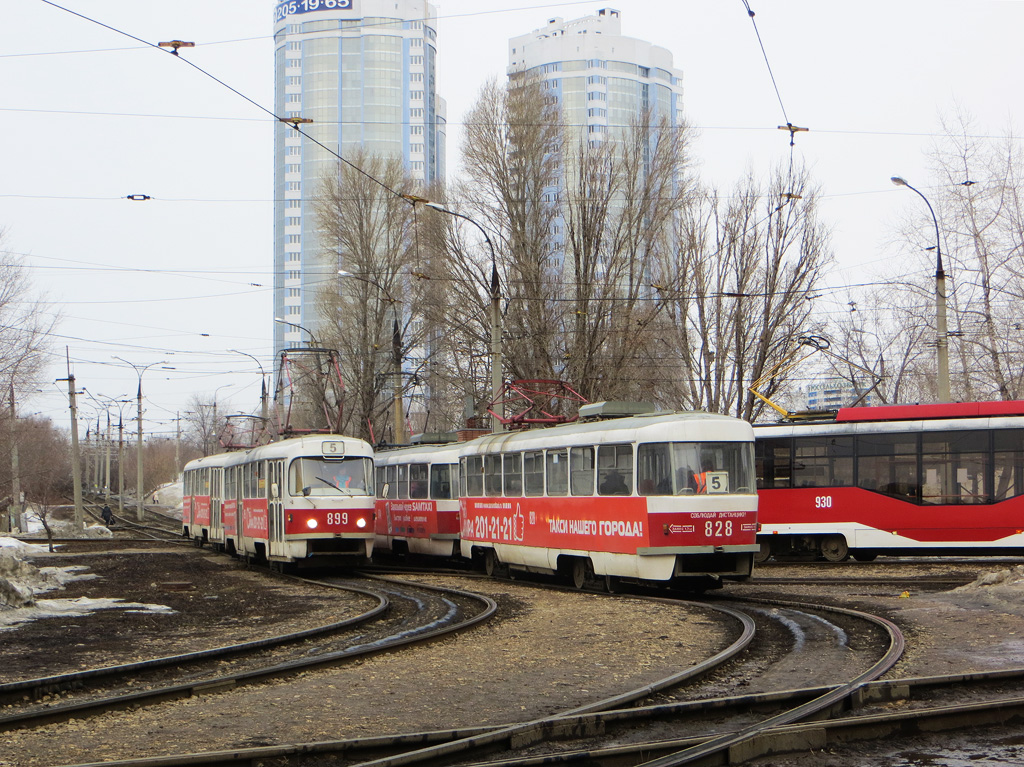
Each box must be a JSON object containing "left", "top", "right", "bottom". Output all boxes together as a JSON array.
[{"left": 0, "top": 0, "right": 1024, "bottom": 432}]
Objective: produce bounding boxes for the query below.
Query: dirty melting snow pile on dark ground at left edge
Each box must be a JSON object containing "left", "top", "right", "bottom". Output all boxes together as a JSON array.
[{"left": 0, "top": 527, "right": 174, "bottom": 631}]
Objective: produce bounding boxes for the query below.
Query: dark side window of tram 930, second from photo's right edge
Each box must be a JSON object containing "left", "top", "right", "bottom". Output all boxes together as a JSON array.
[{"left": 921, "top": 431, "right": 990, "bottom": 504}]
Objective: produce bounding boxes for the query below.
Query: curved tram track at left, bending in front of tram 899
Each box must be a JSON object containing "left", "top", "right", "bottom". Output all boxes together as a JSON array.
[{"left": 0, "top": 579, "right": 497, "bottom": 731}]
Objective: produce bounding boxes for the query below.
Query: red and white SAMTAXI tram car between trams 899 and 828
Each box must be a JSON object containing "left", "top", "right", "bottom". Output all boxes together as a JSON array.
[{"left": 374, "top": 443, "right": 462, "bottom": 557}]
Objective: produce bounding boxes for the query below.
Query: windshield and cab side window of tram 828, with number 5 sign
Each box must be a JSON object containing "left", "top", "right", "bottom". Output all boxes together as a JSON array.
[{"left": 637, "top": 442, "right": 757, "bottom": 496}]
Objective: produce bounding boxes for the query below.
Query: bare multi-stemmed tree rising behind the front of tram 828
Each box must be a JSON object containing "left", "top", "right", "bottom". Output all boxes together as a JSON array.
[{"left": 662, "top": 160, "right": 831, "bottom": 420}]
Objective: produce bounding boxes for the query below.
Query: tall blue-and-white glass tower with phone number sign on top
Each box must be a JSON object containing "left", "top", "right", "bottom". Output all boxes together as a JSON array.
[{"left": 273, "top": 0, "right": 445, "bottom": 353}]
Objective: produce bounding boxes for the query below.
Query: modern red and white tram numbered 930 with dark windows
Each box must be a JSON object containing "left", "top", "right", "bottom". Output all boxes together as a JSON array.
[{"left": 755, "top": 401, "right": 1024, "bottom": 561}]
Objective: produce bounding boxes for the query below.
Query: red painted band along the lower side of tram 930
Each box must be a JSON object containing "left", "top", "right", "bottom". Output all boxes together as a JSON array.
[{"left": 758, "top": 486, "right": 1024, "bottom": 544}]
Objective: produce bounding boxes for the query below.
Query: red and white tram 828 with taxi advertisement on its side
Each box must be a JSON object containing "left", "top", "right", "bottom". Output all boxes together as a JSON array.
[{"left": 460, "top": 403, "right": 758, "bottom": 588}]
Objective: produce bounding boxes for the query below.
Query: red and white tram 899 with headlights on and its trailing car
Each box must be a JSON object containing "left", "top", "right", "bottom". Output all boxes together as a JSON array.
[{"left": 182, "top": 434, "right": 374, "bottom": 565}]
